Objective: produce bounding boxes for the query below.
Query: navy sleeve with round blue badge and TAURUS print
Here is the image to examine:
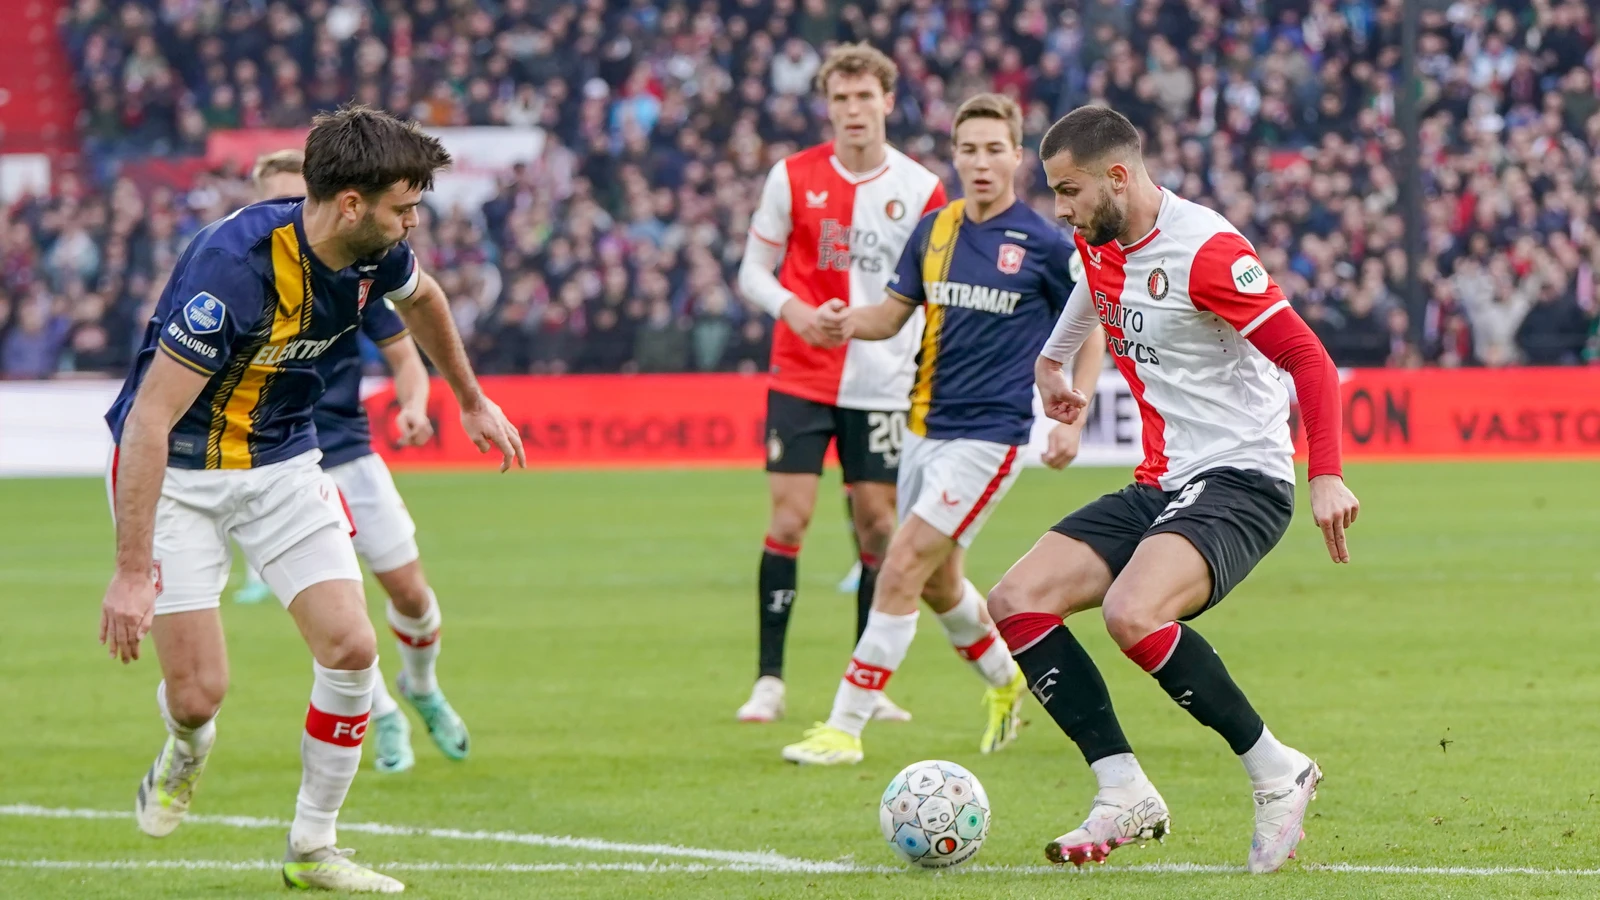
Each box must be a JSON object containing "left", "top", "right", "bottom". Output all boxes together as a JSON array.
[{"left": 160, "top": 250, "right": 267, "bottom": 375}]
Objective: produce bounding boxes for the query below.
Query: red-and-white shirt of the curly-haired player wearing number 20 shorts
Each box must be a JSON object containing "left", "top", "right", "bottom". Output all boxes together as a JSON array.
[{"left": 750, "top": 143, "right": 944, "bottom": 410}]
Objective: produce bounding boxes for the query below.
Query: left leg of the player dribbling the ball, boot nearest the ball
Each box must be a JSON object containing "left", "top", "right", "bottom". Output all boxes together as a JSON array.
[{"left": 989, "top": 485, "right": 1171, "bottom": 865}]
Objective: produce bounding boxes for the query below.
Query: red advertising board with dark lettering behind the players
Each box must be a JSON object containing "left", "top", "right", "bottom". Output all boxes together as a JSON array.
[{"left": 366, "top": 367, "right": 1600, "bottom": 468}]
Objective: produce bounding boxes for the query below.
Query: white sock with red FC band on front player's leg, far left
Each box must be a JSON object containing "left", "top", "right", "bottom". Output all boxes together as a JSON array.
[{"left": 290, "top": 660, "right": 382, "bottom": 854}]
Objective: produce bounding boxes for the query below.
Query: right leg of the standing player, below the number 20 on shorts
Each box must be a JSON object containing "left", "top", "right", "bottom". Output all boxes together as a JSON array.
[{"left": 832, "top": 407, "right": 910, "bottom": 722}]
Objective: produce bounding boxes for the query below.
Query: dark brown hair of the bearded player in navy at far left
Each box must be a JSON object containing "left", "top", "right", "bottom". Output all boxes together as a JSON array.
[{"left": 304, "top": 104, "right": 450, "bottom": 200}]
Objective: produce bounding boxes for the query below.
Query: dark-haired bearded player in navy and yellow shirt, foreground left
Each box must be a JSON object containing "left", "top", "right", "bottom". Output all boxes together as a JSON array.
[{"left": 101, "top": 106, "right": 523, "bottom": 892}]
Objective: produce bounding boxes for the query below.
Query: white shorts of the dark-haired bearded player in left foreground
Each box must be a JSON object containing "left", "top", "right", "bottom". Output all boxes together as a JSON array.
[{"left": 106, "top": 447, "right": 362, "bottom": 615}]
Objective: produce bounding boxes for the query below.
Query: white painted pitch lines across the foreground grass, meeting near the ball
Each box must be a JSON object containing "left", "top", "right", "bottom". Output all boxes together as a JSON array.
[{"left": 9, "top": 804, "right": 1600, "bottom": 878}]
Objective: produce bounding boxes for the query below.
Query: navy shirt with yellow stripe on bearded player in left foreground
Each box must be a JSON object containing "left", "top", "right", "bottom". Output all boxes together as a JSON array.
[{"left": 106, "top": 199, "right": 419, "bottom": 469}]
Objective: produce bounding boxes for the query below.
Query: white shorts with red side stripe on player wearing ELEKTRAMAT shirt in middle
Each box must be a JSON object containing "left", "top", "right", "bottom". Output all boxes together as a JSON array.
[{"left": 896, "top": 432, "right": 1022, "bottom": 548}]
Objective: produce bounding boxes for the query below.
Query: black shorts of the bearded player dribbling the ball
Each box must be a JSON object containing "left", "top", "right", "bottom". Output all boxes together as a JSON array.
[{"left": 1050, "top": 468, "right": 1294, "bottom": 620}]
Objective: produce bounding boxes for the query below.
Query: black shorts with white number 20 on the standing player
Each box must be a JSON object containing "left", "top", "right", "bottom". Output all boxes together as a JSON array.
[{"left": 766, "top": 391, "right": 906, "bottom": 484}]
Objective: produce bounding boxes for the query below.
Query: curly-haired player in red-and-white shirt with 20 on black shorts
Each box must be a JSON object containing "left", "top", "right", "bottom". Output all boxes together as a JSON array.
[{"left": 738, "top": 43, "right": 944, "bottom": 722}]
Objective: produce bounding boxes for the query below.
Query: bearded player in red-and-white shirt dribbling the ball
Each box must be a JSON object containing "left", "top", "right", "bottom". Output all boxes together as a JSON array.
[{"left": 989, "top": 106, "right": 1357, "bottom": 873}]
